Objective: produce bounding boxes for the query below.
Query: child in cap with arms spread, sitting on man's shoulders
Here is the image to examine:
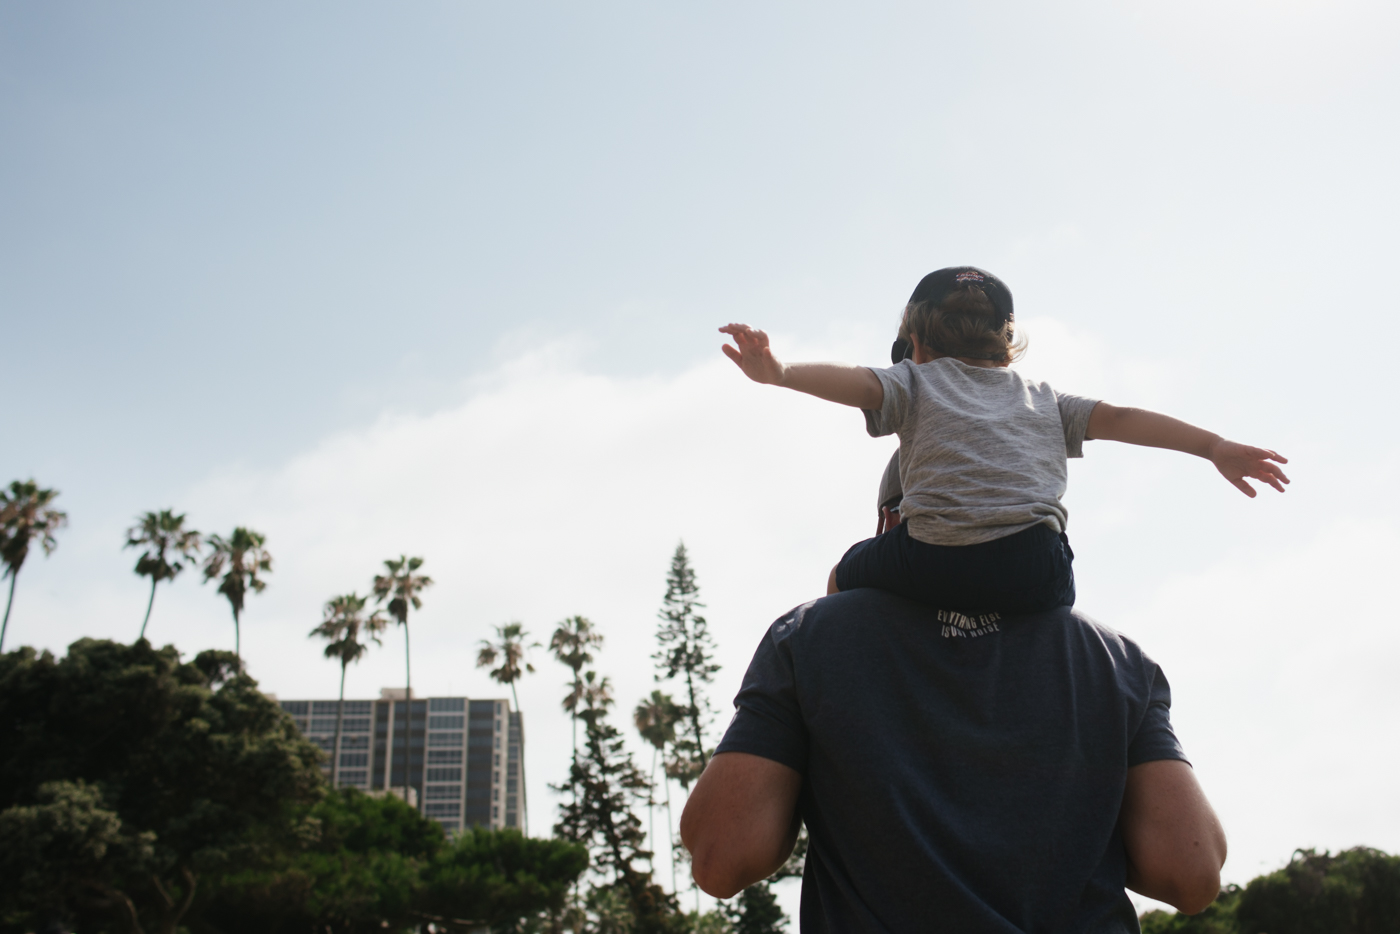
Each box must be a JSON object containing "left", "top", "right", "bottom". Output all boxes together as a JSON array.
[{"left": 720, "top": 266, "right": 1288, "bottom": 615}]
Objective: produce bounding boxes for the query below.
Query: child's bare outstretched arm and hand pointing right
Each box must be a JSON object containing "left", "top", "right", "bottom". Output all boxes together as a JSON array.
[{"left": 1085, "top": 402, "right": 1288, "bottom": 497}]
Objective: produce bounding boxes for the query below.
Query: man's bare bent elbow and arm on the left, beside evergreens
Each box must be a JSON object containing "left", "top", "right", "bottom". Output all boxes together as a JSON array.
[{"left": 680, "top": 752, "right": 802, "bottom": 899}]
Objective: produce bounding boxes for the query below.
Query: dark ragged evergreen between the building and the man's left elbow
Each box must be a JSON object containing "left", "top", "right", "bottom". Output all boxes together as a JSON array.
[{"left": 553, "top": 671, "right": 682, "bottom": 934}]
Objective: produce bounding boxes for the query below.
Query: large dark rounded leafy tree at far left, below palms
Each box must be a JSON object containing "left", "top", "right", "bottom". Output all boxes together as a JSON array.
[{"left": 0, "top": 639, "right": 322, "bottom": 933}]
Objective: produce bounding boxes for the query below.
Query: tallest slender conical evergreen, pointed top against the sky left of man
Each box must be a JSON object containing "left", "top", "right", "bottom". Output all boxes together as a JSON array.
[{"left": 652, "top": 542, "right": 720, "bottom": 790}]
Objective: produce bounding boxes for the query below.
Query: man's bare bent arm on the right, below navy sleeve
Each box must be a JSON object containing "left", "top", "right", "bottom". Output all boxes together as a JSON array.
[{"left": 1119, "top": 759, "right": 1225, "bottom": 914}]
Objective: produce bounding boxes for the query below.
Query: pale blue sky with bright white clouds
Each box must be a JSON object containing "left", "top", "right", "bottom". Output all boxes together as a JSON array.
[{"left": 0, "top": 0, "right": 1400, "bottom": 909}]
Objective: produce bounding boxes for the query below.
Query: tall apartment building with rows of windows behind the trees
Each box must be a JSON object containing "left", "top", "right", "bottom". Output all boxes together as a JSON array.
[{"left": 280, "top": 688, "right": 525, "bottom": 833}]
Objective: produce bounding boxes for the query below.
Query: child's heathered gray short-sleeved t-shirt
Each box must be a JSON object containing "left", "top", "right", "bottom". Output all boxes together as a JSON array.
[{"left": 865, "top": 357, "right": 1098, "bottom": 545}]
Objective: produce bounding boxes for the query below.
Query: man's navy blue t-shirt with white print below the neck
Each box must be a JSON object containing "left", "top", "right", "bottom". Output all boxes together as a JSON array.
[{"left": 717, "top": 590, "right": 1184, "bottom": 934}]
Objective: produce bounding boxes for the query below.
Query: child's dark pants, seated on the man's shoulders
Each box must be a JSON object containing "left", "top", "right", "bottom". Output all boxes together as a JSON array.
[{"left": 836, "top": 522, "right": 1074, "bottom": 615}]
